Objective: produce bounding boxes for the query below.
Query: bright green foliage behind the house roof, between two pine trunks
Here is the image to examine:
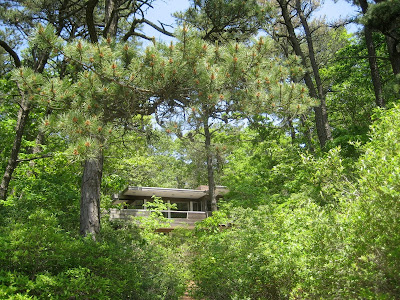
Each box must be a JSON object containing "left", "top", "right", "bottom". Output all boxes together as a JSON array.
[{"left": 102, "top": 125, "right": 192, "bottom": 191}]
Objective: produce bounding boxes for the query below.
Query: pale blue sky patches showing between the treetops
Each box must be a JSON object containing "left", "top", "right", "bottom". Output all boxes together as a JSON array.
[{"left": 144, "top": 0, "right": 357, "bottom": 42}]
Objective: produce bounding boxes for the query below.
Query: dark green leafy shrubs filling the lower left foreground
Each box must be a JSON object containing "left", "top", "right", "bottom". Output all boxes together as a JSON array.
[{"left": 0, "top": 210, "right": 188, "bottom": 299}]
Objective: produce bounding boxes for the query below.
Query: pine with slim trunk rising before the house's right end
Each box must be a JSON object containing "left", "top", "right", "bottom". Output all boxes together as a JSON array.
[{"left": 157, "top": 27, "right": 311, "bottom": 211}]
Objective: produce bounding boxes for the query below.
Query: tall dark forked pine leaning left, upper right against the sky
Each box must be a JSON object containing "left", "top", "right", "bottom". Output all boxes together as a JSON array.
[{"left": 263, "top": 0, "right": 340, "bottom": 148}]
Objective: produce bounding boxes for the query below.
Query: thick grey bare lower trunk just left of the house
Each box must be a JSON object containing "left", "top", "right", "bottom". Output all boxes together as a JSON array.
[{"left": 80, "top": 153, "right": 103, "bottom": 239}]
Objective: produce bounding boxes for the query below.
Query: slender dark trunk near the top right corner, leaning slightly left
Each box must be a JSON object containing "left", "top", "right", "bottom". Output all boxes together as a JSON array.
[{"left": 359, "top": 0, "right": 385, "bottom": 107}]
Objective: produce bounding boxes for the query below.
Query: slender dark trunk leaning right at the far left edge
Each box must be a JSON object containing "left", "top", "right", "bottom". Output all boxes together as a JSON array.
[{"left": 0, "top": 90, "right": 29, "bottom": 200}]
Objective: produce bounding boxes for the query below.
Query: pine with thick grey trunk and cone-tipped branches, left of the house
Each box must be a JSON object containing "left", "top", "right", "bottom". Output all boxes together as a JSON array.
[{"left": 16, "top": 22, "right": 184, "bottom": 234}]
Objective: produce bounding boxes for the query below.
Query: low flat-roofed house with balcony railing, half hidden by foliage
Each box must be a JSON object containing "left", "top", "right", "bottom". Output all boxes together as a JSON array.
[{"left": 110, "top": 185, "right": 228, "bottom": 231}]
